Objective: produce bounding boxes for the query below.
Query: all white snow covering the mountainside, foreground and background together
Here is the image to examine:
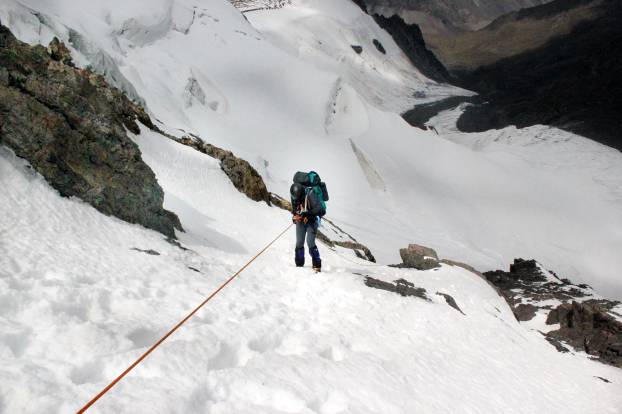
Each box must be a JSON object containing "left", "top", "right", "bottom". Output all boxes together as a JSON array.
[{"left": 0, "top": 0, "right": 622, "bottom": 414}]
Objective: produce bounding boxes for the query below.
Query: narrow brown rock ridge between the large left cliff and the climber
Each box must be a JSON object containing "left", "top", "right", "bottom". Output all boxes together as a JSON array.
[{"left": 177, "top": 135, "right": 270, "bottom": 204}]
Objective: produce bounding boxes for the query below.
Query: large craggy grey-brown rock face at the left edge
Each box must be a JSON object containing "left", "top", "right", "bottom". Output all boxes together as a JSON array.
[{"left": 0, "top": 26, "right": 181, "bottom": 237}]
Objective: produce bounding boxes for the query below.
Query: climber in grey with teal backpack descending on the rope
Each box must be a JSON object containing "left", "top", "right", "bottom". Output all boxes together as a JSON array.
[{"left": 289, "top": 171, "right": 328, "bottom": 272}]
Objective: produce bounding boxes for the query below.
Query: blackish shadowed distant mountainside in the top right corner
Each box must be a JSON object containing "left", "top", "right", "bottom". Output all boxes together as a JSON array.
[{"left": 454, "top": 0, "right": 622, "bottom": 149}]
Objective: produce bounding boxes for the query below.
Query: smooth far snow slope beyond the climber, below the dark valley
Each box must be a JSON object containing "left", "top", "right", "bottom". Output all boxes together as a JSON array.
[{"left": 0, "top": 0, "right": 622, "bottom": 298}]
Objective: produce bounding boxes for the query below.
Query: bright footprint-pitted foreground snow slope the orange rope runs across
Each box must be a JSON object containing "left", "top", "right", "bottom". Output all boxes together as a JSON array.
[{"left": 0, "top": 137, "right": 622, "bottom": 414}]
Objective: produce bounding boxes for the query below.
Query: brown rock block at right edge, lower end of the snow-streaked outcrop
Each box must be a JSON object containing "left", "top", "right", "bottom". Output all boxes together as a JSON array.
[{"left": 546, "top": 301, "right": 622, "bottom": 368}]
